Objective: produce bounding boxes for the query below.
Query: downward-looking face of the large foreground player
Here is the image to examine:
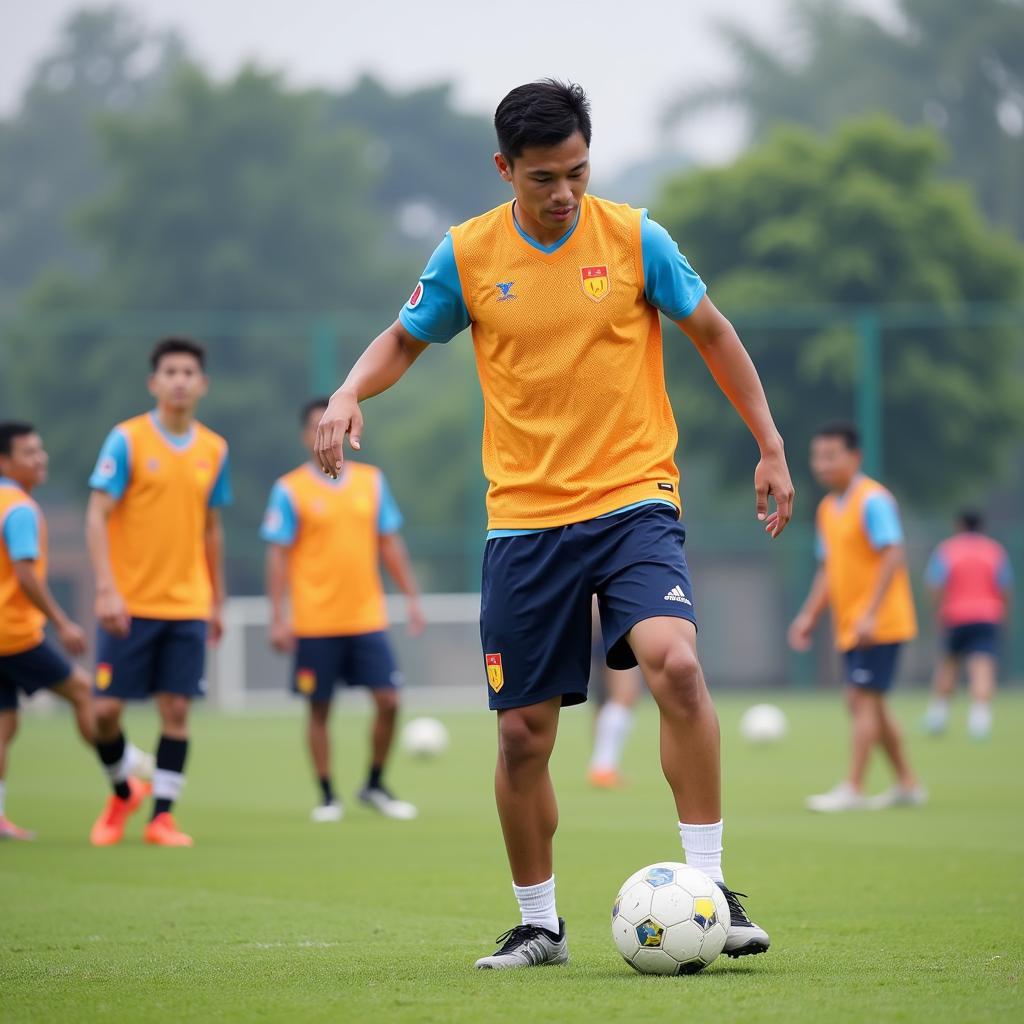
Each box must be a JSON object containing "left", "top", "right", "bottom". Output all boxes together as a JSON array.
[{"left": 495, "top": 132, "right": 590, "bottom": 232}]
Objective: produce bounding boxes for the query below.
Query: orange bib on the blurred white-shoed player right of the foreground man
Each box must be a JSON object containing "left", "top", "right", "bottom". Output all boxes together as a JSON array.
[{"left": 817, "top": 476, "right": 918, "bottom": 651}]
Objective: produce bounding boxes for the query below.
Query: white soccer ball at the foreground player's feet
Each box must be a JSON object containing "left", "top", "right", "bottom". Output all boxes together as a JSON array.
[{"left": 611, "top": 861, "right": 731, "bottom": 974}]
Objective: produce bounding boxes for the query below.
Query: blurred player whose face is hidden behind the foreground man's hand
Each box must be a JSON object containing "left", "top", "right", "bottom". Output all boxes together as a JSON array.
[{"left": 261, "top": 398, "right": 423, "bottom": 821}]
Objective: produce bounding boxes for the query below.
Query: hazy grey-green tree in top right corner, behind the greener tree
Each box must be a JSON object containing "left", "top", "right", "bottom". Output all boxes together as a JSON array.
[{"left": 669, "top": 0, "right": 1024, "bottom": 237}]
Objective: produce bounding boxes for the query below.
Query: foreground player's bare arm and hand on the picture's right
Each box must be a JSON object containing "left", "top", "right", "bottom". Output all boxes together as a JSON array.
[{"left": 677, "top": 296, "right": 794, "bottom": 538}]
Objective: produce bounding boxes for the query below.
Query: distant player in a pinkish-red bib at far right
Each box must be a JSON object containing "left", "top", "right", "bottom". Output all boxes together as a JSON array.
[{"left": 925, "top": 509, "right": 1013, "bottom": 739}]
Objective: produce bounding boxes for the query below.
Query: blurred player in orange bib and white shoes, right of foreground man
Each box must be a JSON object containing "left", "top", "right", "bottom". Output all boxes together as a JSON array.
[{"left": 790, "top": 423, "right": 926, "bottom": 811}]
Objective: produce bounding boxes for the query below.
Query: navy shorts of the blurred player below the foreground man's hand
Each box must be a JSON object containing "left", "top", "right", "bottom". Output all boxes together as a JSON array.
[{"left": 292, "top": 630, "right": 401, "bottom": 702}]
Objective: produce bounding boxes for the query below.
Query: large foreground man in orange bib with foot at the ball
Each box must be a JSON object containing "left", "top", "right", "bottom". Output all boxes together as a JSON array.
[{"left": 316, "top": 80, "right": 793, "bottom": 969}]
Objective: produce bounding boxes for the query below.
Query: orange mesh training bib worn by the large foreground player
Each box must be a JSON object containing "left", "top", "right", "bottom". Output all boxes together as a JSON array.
[{"left": 413, "top": 196, "right": 703, "bottom": 529}]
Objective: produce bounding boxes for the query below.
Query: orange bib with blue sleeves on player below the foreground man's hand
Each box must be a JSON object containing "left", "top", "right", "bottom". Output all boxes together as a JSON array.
[{"left": 260, "top": 462, "right": 401, "bottom": 637}]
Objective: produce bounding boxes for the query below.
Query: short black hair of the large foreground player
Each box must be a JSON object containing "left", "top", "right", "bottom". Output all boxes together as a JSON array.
[{"left": 495, "top": 78, "right": 590, "bottom": 164}]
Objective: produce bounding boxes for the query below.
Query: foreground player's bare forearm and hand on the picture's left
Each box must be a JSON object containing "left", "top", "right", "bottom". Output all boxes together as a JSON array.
[{"left": 315, "top": 321, "right": 429, "bottom": 479}]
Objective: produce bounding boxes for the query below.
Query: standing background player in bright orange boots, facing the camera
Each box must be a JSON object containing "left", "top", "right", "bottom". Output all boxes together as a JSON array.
[{"left": 86, "top": 338, "right": 230, "bottom": 846}]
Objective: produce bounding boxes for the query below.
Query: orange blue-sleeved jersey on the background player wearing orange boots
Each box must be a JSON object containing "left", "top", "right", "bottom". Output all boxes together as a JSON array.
[{"left": 89, "top": 413, "right": 230, "bottom": 620}]
